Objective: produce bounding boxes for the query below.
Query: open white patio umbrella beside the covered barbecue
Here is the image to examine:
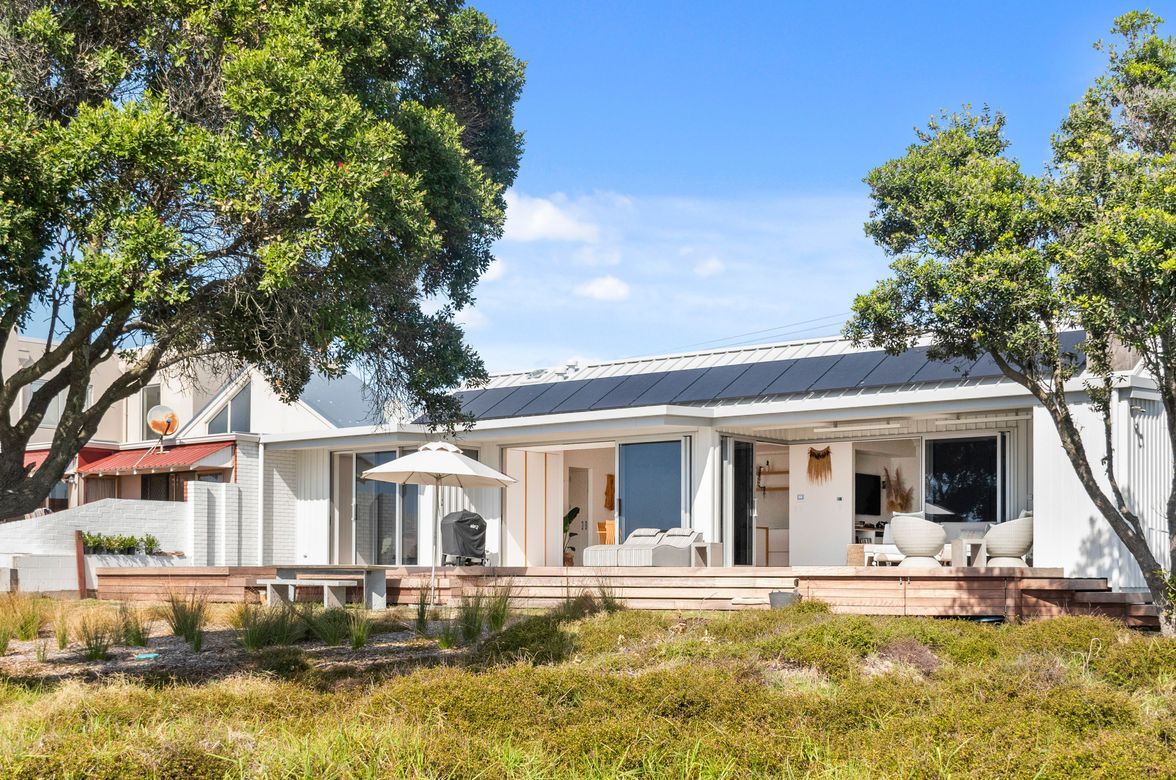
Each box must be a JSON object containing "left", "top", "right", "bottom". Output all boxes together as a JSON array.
[{"left": 360, "top": 441, "right": 515, "bottom": 600}]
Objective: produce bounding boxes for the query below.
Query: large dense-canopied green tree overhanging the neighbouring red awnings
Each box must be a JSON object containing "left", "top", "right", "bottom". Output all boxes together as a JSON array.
[{"left": 0, "top": 0, "right": 523, "bottom": 518}]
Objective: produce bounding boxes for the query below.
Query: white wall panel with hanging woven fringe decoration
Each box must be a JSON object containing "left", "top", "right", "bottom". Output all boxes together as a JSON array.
[{"left": 788, "top": 441, "right": 854, "bottom": 566}]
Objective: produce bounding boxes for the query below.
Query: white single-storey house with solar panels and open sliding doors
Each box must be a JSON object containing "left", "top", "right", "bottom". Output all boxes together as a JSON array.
[{"left": 262, "top": 333, "right": 1172, "bottom": 589}]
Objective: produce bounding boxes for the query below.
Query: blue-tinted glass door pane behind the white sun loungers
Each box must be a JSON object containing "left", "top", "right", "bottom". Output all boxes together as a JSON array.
[{"left": 617, "top": 441, "right": 682, "bottom": 539}]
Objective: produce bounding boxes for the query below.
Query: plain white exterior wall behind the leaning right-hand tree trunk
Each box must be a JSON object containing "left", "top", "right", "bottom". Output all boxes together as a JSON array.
[{"left": 1034, "top": 391, "right": 1172, "bottom": 589}]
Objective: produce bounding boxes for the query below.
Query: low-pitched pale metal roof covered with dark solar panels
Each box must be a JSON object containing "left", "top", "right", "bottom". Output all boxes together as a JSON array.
[{"left": 446, "top": 331, "right": 1085, "bottom": 420}]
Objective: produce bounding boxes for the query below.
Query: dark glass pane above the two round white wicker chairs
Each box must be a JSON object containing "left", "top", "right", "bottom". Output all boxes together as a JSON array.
[{"left": 926, "top": 436, "right": 1001, "bottom": 522}]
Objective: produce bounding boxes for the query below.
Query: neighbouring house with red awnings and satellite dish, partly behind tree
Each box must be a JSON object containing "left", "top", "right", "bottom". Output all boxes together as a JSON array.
[{"left": 0, "top": 334, "right": 379, "bottom": 589}]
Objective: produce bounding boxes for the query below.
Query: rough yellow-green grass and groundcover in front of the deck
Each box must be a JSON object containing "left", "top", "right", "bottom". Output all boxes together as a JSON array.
[{"left": 0, "top": 599, "right": 1176, "bottom": 778}]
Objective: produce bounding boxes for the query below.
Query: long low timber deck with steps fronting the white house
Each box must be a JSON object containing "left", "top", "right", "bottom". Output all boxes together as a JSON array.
[{"left": 96, "top": 566, "right": 1158, "bottom": 628}]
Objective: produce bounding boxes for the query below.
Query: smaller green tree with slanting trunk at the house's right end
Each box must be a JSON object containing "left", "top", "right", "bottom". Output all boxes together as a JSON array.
[{"left": 848, "top": 13, "right": 1176, "bottom": 614}]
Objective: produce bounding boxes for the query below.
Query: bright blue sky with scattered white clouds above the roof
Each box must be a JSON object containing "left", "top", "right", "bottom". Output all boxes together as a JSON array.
[{"left": 461, "top": 0, "right": 1176, "bottom": 372}]
